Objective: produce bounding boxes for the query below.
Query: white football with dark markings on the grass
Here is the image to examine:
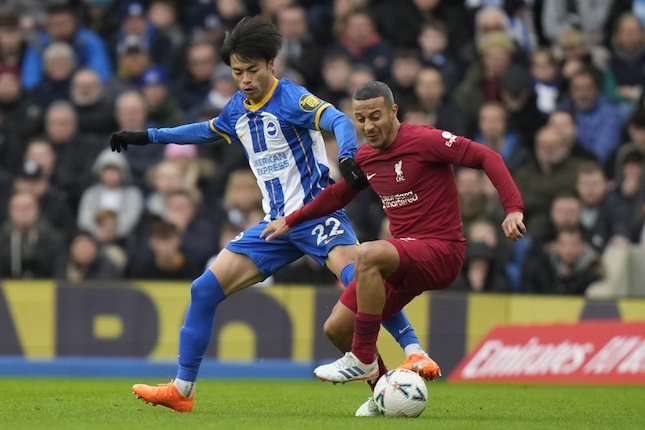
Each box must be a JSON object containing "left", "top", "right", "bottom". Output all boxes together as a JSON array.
[{"left": 374, "top": 369, "right": 428, "bottom": 418}]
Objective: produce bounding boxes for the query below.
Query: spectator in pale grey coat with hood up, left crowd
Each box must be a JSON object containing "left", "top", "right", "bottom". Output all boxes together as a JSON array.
[{"left": 78, "top": 149, "right": 143, "bottom": 238}]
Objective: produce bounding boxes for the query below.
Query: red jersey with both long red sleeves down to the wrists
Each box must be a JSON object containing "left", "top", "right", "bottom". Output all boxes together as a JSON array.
[{"left": 286, "top": 123, "right": 524, "bottom": 241}]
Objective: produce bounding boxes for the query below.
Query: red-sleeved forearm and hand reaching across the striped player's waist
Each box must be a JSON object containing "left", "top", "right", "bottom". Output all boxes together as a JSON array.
[{"left": 260, "top": 179, "right": 361, "bottom": 240}]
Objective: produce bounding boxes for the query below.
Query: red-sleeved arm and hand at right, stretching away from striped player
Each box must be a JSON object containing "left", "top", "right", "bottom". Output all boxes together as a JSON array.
[{"left": 457, "top": 137, "right": 526, "bottom": 240}]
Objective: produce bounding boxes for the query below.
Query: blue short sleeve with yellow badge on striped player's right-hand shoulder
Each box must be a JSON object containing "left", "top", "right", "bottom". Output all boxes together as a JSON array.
[{"left": 281, "top": 84, "right": 331, "bottom": 130}]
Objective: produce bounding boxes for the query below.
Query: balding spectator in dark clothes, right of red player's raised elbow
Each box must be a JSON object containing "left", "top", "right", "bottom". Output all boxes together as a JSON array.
[{"left": 515, "top": 126, "right": 581, "bottom": 232}]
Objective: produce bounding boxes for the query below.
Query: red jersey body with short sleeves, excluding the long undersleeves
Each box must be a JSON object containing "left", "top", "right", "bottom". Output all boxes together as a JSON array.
[{"left": 355, "top": 123, "right": 468, "bottom": 240}]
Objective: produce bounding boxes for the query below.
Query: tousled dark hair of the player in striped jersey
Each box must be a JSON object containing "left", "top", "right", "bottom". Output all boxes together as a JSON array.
[{"left": 222, "top": 15, "right": 282, "bottom": 66}]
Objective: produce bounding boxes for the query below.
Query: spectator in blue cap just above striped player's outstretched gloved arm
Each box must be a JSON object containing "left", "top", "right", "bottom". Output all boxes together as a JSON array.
[{"left": 141, "top": 66, "right": 186, "bottom": 127}]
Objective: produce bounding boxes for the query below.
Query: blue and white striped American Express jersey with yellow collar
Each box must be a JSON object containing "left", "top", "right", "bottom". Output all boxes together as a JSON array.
[{"left": 209, "top": 79, "right": 342, "bottom": 221}]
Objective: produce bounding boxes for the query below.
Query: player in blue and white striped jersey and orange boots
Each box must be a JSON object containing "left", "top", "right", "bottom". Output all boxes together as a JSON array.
[{"left": 110, "top": 17, "right": 438, "bottom": 412}]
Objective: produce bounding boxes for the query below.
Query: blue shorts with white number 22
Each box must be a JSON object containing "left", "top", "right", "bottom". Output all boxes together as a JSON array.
[{"left": 226, "top": 210, "right": 358, "bottom": 277}]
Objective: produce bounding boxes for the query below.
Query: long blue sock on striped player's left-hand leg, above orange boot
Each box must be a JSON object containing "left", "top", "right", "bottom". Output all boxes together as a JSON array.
[{"left": 177, "top": 270, "right": 226, "bottom": 382}]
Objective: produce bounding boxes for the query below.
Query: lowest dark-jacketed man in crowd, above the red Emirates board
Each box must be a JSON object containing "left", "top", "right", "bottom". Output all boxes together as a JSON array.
[{"left": 523, "top": 228, "right": 603, "bottom": 295}]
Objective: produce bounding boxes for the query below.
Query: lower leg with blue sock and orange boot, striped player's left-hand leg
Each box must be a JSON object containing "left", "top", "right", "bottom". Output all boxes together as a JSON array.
[{"left": 132, "top": 270, "right": 225, "bottom": 412}]
